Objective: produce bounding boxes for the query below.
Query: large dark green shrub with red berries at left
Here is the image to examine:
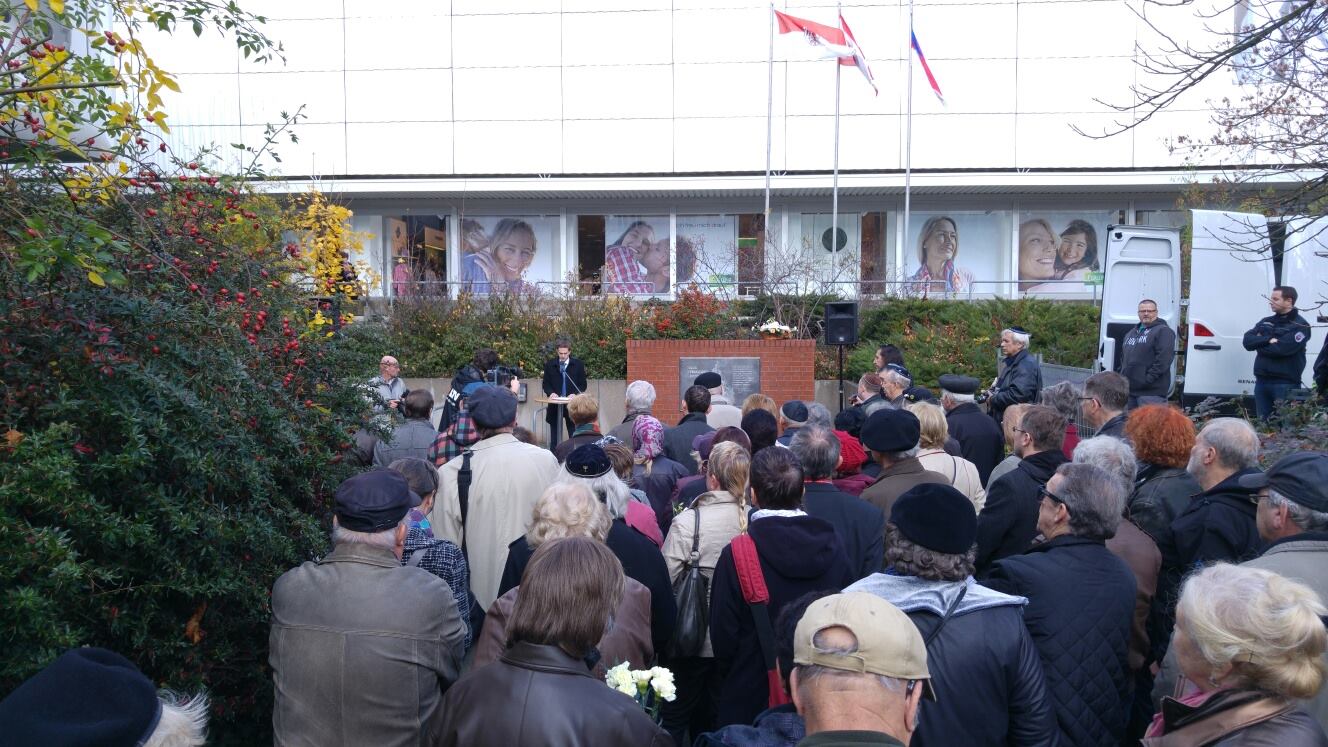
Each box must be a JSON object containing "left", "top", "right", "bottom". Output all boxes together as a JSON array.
[{"left": 0, "top": 182, "right": 382, "bottom": 744}]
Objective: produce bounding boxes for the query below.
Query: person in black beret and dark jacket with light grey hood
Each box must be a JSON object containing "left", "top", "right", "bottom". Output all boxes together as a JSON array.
[{"left": 845, "top": 484, "right": 1057, "bottom": 747}]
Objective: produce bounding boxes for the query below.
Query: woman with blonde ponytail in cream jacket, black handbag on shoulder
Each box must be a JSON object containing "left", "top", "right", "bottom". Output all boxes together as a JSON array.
[{"left": 663, "top": 441, "right": 752, "bottom": 744}]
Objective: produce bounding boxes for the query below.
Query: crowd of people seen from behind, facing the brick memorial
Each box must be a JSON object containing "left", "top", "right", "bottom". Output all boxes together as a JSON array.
[{"left": 0, "top": 313, "right": 1328, "bottom": 747}]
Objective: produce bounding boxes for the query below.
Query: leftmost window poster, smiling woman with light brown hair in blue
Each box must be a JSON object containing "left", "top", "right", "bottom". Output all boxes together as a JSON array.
[{"left": 459, "top": 215, "right": 558, "bottom": 295}]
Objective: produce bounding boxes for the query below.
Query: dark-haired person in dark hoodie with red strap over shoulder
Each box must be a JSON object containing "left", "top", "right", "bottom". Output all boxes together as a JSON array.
[{"left": 710, "top": 449, "right": 857, "bottom": 726}]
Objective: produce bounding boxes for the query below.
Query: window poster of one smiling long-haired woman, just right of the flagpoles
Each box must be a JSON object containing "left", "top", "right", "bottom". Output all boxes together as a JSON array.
[{"left": 903, "top": 211, "right": 1009, "bottom": 298}]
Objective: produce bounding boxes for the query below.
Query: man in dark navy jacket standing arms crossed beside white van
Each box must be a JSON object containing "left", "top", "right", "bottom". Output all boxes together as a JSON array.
[{"left": 1243, "top": 286, "right": 1309, "bottom": 419}]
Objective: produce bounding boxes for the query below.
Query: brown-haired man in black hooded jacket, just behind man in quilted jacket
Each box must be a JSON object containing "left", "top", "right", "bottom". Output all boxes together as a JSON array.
[{"left": 977, "top": 404, "right": 1069, "bottom": 576}]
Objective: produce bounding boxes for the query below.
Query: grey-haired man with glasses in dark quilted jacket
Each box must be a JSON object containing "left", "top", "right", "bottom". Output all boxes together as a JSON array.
[{"left": 984, "top": 464, "right": 1135, "bottom": 747}]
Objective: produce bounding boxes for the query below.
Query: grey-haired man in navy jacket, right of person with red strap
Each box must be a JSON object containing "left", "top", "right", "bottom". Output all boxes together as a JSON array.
[{"left": 789, "top": 425, "right": 886, "bottom": 578}]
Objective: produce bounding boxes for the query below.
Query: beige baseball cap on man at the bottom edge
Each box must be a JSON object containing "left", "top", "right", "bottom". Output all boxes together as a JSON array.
[{"left": 793, "top": 591, "right": 936, "bottom": 700}]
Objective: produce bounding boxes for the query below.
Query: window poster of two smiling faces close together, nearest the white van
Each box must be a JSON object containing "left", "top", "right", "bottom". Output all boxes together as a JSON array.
[{"left": 1015, "top": 210, "right": 1117, "bottom": 295}]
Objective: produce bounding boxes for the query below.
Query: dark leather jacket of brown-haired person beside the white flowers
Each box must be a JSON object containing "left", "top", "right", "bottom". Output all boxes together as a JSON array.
[{"left": 438, "top": 642, "right": 673, "bottom": 747}]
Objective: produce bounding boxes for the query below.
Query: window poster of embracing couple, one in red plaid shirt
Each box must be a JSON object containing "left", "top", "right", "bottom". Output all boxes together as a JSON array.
[{"left": 600, "top": 215, "right": 669, "bottom": 294}]
